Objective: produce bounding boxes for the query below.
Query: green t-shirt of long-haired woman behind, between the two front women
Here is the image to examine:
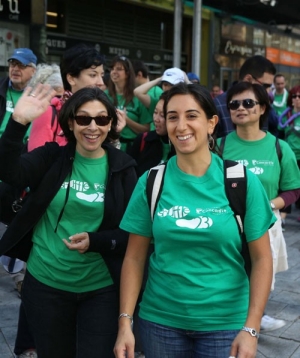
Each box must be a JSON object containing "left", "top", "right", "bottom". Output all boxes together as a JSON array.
[{"left": 105, "top": 90, "right": 152, "bottom": 150}]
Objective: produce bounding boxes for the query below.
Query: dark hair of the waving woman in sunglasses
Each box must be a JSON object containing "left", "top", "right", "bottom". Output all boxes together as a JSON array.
[{"left": 58, "top": 87, "right": 119, "bottom": 142}]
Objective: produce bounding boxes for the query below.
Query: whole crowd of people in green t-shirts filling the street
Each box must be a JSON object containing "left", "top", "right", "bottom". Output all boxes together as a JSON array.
[{"left": 0, "top": 45, "right": 300, "bottom": 358}]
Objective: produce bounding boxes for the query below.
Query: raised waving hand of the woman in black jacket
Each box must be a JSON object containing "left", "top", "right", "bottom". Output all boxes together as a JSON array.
[{"left": 12, "top": 84, "right": 56, "bottom": 125}]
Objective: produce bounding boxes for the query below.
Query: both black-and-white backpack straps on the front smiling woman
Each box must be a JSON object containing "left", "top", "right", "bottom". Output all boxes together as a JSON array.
[{"left": 146, "top": 160, "right": 251, "bottom": 277}]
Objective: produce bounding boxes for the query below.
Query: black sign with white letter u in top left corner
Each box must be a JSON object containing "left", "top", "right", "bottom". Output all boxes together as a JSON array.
[{"left": 0, "top": 0, "right": 31, "bottom": 23}]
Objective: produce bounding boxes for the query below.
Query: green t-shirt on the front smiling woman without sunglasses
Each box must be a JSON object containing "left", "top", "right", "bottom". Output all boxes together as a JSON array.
[{"left": 120, "top": 154, "right": 275, "bottom": 331}]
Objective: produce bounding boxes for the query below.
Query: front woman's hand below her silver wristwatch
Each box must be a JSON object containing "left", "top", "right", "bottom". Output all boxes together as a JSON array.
[{"left": 230, "top": 331, "right": 257, "bottom": 358}]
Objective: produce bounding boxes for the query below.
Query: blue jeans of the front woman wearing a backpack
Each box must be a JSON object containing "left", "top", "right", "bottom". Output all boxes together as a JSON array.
[{"left": 139, "top": 318, "right": 239, "bottom": 358}]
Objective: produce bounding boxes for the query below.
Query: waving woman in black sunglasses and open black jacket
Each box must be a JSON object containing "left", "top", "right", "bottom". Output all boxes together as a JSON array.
[{"left": 0, "top": 85, "right": 136, "bottom": 358}]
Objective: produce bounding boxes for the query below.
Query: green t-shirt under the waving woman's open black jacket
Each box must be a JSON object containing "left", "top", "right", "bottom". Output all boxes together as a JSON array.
[{"left": 27, "top": 153, "right": 113, "bottom": 292}]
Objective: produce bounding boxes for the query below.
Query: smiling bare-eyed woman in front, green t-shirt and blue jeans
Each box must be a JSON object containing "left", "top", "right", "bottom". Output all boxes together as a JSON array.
[{"left": 114, "top": 84, "right": 274, "bottom": 358}]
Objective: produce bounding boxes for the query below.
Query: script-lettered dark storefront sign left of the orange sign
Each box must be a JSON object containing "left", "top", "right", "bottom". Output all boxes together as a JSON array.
[{"left": 221, "top": 39, "right": 266, "bottom": 57}]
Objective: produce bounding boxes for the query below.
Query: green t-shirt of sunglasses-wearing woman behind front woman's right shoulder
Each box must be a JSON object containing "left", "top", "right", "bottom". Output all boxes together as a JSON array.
[{"left": 218, "top": 131, "right": 300, "bottom": 200}]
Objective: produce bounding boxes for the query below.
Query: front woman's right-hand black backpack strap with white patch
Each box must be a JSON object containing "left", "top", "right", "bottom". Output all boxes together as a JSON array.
[{"left": 224, "top": 160, "right": 251, "bottom": 278}]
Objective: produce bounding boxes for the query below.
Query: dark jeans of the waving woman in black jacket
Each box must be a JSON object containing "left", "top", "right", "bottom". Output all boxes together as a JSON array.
[{"left": 22, "top": 271, "right": 119, "bottom": 358}]
